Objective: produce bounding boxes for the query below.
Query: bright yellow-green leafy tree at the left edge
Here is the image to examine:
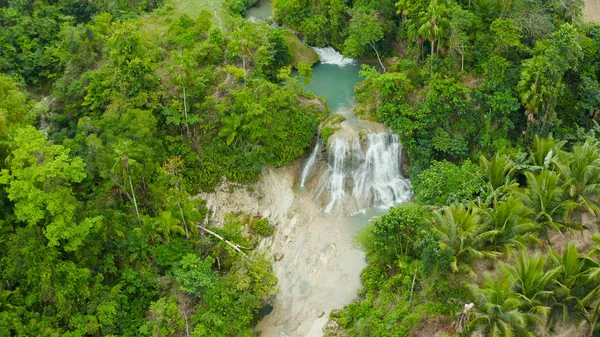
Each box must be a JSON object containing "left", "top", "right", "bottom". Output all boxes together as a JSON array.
[{"left": 0, "top": 126, "right": 101, "bottom": 251}]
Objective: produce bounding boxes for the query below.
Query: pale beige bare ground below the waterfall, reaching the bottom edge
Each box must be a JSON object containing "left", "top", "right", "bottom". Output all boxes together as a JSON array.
[{"left": 202, "top": 166, "right": 366, "bottom": 337}]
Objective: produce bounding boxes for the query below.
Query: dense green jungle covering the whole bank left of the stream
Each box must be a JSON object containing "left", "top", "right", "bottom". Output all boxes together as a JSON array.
[{"left": 0, "top": 0, "right": 326, "bottom": 336}]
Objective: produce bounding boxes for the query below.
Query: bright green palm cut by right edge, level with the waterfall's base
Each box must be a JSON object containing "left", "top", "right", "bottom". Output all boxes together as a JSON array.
[{"left": 554, "top": 141, "right": 600, "bottom": 215}]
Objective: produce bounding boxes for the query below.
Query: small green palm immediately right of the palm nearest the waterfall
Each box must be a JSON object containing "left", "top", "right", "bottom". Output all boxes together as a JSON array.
[{"left": 483, "top": 196, "right": 541, "bottom": 253}]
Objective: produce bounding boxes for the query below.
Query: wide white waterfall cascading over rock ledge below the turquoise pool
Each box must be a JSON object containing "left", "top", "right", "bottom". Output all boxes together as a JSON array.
[{"left": 303, "top": 132, "right": 411, "bottom": 213}]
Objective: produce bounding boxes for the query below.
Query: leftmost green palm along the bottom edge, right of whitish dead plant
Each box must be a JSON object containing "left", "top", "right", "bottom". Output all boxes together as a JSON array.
[{"left": 469, "top": 273, "right": 535, "bottom": 337}]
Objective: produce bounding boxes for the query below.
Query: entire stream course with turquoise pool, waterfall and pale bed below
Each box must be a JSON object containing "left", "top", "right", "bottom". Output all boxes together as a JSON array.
[{"left": 211, "top": 0, "right": 411, "bottom": 337}]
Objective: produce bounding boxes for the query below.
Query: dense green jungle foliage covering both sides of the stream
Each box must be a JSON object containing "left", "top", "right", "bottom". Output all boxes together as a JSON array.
[{"left": 0, "top": 0, "right": 600, "bottom": 337}]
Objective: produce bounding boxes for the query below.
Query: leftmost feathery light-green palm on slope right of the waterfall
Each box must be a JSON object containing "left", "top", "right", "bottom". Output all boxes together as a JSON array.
[{"left": 432, "top": 205, "right": 500, "bottom": 276}]
